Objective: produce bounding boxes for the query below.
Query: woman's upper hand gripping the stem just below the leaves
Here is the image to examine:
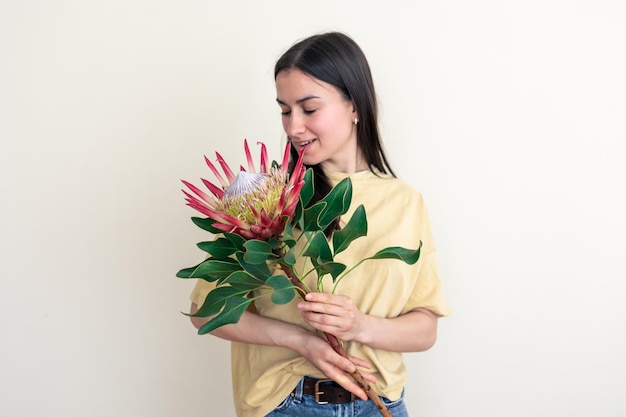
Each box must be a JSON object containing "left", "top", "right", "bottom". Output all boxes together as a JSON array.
[{"left": 298, "top": 293, "right": 365, "bottom": 341}]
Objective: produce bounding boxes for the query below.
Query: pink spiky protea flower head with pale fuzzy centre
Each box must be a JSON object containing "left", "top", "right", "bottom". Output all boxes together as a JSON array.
[{"left": 183, "top": 140, "right": 305, "bottom": 241}]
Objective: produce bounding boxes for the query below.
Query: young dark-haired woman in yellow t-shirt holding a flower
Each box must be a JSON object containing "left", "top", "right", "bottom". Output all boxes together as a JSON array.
[{"left": 191, "top": 32, "right": 448, "bottom": 417}]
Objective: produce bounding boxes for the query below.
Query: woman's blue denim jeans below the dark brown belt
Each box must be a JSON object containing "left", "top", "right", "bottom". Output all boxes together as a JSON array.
[{"left": 266, "top": 380, "right": 409, "bottom": 417}]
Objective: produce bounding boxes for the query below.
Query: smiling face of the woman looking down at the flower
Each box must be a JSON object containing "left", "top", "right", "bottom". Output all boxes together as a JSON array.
[{"left": 276, "top": 69, "right": 367, "bottom": 173}]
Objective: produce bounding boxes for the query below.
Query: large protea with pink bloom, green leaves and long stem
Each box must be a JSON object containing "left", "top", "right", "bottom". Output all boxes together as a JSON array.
[{"left": 176, "top": 141, "right": 420, "bottom": 416}]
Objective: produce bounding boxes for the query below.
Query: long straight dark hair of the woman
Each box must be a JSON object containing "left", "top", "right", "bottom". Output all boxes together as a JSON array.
[{"left": 274, "top": 32, "right": 395, "bottom": 234}]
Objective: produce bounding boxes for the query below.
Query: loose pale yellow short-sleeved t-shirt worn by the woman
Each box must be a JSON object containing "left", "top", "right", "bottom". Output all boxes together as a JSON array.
[{"left": 191, "top": 170, "right": 449, "bottom": 417}]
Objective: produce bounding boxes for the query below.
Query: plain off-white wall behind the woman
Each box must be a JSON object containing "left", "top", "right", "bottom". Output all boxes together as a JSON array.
[{"left": 0, "top": 0, "right": 626, "bottom": 417}]
